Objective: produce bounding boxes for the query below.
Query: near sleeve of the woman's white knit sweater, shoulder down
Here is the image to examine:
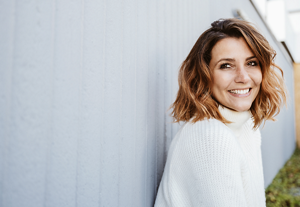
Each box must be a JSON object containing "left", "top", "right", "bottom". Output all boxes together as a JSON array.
[{"left": 157, "top": 120, "right": 247, "bottom": 207}]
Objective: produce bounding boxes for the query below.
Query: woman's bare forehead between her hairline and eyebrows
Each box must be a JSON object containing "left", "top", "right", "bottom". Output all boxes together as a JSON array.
[{"left": 211, "top": 37, "right": 254, "bottom": 61}]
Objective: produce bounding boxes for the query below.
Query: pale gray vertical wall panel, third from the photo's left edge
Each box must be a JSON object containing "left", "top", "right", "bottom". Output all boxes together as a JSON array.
[{"left": 45, "top": 0, "right": 82, "bottom": 207}]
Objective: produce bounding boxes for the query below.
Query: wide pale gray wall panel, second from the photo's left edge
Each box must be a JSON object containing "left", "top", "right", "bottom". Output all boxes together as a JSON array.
[{"left": 1, "top": 1, "right": 53, "bottom": 207}]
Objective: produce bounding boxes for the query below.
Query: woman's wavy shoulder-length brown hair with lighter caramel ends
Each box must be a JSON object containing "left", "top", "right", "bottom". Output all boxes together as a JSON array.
[{"left": 170, "top": 19, "right": 286, "bottom": 128}]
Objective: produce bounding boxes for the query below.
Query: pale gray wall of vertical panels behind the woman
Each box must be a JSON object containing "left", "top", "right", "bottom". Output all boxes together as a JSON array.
[{"left": 0, "top": 0, "right": 295, "bottom": 207}]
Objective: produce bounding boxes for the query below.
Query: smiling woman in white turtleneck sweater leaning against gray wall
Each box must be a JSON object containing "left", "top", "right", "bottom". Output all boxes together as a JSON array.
[{"left": 155, "top": 19, "right": 286, "bottom": 207}]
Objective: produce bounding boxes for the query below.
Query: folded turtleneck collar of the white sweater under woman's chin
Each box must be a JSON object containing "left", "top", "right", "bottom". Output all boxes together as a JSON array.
[{"left": 218, "top": 105, "right": 252, "bottom": 137}]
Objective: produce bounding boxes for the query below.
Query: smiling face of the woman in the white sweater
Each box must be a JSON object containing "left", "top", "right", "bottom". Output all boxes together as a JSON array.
[{"left": 209, "top": 37, "right": 262, "bottom": 111}]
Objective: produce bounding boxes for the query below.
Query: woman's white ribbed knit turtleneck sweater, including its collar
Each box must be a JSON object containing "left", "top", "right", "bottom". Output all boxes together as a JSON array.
[{"left": 155, "top": 107, "right": 266, "bottom": 207}]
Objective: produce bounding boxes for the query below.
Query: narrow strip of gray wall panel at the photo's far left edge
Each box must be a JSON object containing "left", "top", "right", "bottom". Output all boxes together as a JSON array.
[{"left": 0, "top": 1, "right": 15, "bottom": 206}]
